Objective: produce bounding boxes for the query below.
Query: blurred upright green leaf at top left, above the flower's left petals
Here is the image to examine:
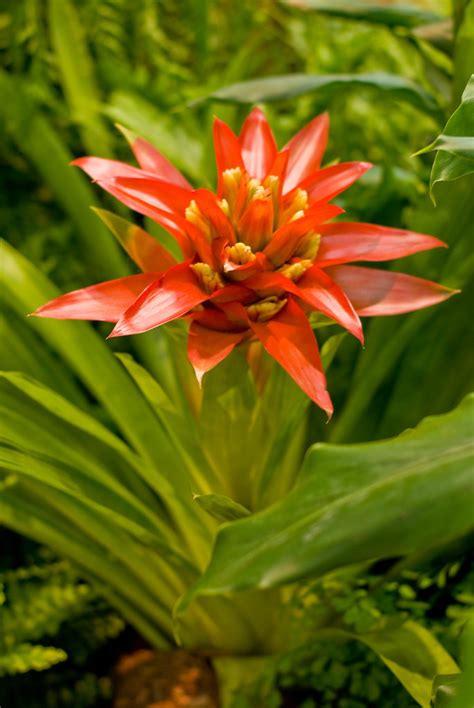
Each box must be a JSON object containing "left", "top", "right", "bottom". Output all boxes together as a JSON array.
[{"left": 48, "top": 0, "right": 112, "bottom": 157}]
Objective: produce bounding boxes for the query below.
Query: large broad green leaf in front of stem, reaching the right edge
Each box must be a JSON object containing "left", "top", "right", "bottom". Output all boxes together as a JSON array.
[{"left": 180, "top": 397, "right": 474, "bottom": 611}]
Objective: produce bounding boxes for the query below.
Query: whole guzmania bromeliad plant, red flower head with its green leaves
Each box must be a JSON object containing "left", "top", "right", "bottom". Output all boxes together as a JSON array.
[{"left": 5, "top": 109, "right": 472, "bottom": 706}]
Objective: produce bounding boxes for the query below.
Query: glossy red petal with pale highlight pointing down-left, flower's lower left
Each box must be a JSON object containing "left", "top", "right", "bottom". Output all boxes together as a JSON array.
[{"left": 109, "top": 262, "right": 209, "bottom": 337}]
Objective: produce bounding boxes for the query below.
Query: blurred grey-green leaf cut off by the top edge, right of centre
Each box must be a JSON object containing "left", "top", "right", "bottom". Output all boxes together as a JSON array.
[{"left": 285, "top": 0, "right": 442, "bottom": 28}]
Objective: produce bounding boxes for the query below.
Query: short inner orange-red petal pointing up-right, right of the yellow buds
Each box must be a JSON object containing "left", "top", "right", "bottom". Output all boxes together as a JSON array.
[{"left": 263, "top": 204, "right": 343, "bottom": 266}]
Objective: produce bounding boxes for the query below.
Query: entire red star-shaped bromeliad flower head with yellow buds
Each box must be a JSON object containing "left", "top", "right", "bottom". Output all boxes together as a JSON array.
[{"left": 35, "top": 108, "right": 454, "bottom": 416}]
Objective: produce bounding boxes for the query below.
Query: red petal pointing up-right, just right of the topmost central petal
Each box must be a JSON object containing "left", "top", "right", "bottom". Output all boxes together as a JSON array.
[{"left": 284, "top": 113, "right": 329, "bottom": 193}]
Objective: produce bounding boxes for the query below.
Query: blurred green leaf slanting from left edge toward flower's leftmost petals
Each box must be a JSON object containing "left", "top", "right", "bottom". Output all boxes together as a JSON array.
[{"left": 0, "top": 70, "right": 127, "bottom": 280}]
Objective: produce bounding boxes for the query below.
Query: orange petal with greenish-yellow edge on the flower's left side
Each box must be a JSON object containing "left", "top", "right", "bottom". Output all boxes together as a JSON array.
[{"left": 94, "top": 209, "right": 176, "bottom": 273}]
